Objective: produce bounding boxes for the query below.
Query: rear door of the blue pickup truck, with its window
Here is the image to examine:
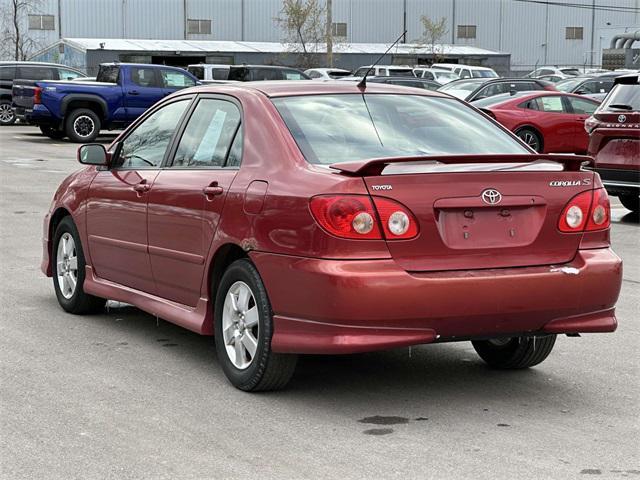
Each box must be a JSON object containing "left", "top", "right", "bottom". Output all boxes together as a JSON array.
[{"left": 121, "top": 66, "right": 164, "bottom": 121}]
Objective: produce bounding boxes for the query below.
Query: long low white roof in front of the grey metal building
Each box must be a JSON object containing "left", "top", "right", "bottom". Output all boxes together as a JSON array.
[{"left": 56, "top": 38, "right": 508, "bottom": 57}]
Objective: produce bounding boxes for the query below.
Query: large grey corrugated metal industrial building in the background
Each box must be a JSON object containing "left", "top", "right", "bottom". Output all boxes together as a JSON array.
[{"left": 8, "top": 0, "right": 640, "bottom": 71}]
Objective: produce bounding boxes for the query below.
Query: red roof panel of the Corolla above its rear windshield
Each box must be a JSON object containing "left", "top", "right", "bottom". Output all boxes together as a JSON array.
[{"left": 182, "top": 77, "right": 449, "bottom": 98}]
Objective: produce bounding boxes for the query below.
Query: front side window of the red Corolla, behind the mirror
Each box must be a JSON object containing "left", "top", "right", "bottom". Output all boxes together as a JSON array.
[{"left": 118, "top": 99, "right": 189, "bottom": 168}]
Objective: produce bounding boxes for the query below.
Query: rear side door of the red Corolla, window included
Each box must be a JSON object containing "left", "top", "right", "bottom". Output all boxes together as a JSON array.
[{"left": 148, "top": 96, "right": 242, "bottom": 307}]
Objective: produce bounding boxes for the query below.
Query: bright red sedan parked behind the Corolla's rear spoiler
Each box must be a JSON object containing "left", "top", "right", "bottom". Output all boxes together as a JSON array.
[{"left": 472, "top": 91, "right": 599, "bottom": 154}]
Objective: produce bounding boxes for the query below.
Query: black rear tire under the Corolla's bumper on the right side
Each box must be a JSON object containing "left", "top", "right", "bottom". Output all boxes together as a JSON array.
[{"left": 471, "top": 335, "right": 556, "bottom": 369}]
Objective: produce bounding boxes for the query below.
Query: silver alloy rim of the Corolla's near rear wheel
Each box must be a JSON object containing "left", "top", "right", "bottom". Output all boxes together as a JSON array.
[{"left": 222, "top": 281, "right": 260, "bottom": 370}]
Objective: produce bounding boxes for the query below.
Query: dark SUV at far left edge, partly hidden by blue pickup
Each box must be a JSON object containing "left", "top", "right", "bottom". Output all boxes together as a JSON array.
[{"left": 0, "top": 62, "right": 86, "bottom": 125}]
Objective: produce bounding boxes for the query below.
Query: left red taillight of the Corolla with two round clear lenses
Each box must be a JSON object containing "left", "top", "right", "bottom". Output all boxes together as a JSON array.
[{"left": 310, "top": 195, "right": 418, "bottom": 240}]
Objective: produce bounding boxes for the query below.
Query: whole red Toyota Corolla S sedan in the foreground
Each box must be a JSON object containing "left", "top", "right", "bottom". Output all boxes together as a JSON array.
[{"left": 42, "top": 82, "right": 622, "bottom": 390}]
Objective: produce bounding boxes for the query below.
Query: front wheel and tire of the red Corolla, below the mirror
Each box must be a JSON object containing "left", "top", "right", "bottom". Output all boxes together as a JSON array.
[{"left": 51, "top": 216, "right": 106, "bottom": 314}]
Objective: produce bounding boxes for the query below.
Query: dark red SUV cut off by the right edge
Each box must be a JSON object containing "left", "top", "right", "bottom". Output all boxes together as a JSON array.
[{"left": 585, "top": 74, "right": 640, "bottom": 213}]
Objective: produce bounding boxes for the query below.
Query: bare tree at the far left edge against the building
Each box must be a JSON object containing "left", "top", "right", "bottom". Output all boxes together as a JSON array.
[{"left": 0, "top": 0, "right": 41, "bottom": 60}]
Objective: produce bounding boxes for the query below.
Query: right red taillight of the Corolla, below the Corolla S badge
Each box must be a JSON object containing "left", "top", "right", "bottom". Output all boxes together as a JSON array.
[{"left": 558, "top": 188, "right": 611, "bottom": 233}]
